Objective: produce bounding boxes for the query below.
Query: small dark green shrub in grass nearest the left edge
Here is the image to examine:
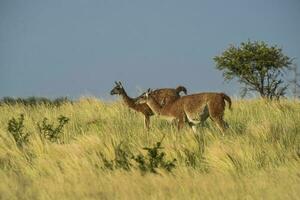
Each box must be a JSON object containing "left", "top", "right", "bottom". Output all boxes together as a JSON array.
[{"left": 7, "top": 114, "right": 29, "bottom": 147}]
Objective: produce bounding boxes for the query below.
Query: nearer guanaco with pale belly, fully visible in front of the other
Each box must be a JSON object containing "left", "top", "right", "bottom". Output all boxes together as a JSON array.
[{"left": 136, "top": 89, "right": 232, "bottom": 135}]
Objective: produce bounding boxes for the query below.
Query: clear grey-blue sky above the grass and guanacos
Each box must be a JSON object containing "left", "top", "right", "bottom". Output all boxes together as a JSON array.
[{"left": 0, "top": 0, "right": 300, "bottom": 99}]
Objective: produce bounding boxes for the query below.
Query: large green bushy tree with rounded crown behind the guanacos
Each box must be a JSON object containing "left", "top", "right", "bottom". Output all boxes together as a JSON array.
[{"left": 214, "top": 40, "right": 293, "bottom": 99}]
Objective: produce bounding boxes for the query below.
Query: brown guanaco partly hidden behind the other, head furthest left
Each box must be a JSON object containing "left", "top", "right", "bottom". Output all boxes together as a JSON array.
[{"left": 110, "top": 81, "right": 187, "bottom": 130}]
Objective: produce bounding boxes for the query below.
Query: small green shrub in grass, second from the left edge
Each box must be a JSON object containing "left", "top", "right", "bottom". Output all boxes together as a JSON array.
[{"left": 37, "top": 115, "right": 70, "bottom": 143}]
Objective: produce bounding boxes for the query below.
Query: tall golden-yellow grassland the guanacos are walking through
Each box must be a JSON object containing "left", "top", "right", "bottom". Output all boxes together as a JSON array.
[{"left": 0, "top": 98, "right": 300, "bottom": 199}]
